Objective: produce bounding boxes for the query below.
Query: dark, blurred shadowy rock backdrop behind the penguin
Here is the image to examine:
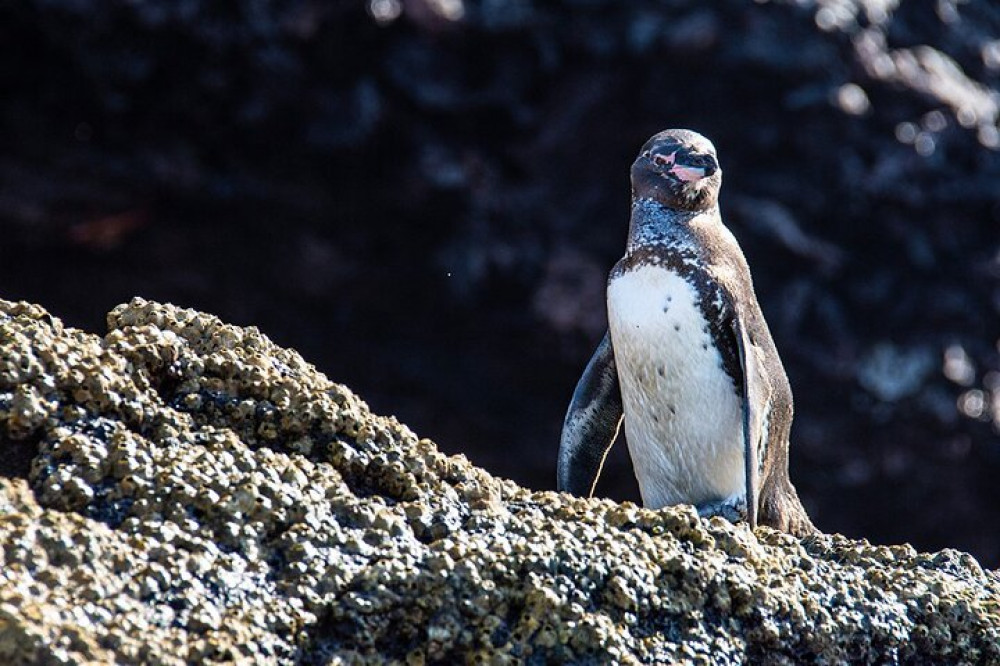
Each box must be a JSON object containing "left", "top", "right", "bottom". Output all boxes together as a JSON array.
[{"left": 0, "top": 0, "right": 1000, "bottom": 567}]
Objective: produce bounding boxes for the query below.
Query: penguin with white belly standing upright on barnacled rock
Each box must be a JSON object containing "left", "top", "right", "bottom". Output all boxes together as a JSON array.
[{"left": 557, "top": 129, "right": 815, "bottom": 536}]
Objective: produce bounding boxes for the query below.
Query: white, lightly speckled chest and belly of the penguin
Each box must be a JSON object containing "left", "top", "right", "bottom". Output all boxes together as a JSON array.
[{"left": 608, "top": 266, "right": 745, "bottom": 508}]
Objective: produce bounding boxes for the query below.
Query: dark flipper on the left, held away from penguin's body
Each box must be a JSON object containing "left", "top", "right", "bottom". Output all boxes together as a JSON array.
[{"left": 556, "top": 333, "right": 622, "bottom": 497}]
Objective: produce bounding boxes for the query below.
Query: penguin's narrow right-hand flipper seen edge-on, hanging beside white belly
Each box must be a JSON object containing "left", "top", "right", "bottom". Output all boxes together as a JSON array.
[{"left": 732, "top": 313, "right": 771, "bottom": 529}]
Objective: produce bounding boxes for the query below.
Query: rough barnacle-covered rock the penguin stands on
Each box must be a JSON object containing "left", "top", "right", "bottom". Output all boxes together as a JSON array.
[{"left": 0, "top": 299, "right": 1000, "bottom": 664}]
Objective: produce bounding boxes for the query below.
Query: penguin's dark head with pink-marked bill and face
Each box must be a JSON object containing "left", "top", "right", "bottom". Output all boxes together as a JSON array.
[{"left": 632, "top": 129, "right": 722, "bottom": 211}]
